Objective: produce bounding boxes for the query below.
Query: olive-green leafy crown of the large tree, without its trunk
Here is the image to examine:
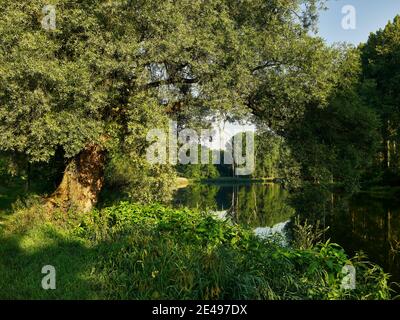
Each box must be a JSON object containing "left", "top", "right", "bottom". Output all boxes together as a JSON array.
[{"left": 0, "top": 0, "right": 332, "bottom": 161}]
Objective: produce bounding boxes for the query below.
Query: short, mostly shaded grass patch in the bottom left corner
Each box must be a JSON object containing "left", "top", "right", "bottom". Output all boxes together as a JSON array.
[{"left": 0, "top": 228, "right": 102, "bottom": 299}]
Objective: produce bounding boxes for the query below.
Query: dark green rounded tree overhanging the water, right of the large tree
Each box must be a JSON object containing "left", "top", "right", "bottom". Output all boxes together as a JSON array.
[{"left": 288, "top": 48, "right": 380, "bottom": 192}]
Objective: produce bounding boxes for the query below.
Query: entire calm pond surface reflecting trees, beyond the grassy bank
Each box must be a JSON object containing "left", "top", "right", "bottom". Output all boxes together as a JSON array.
[{"left": 174, "top": 184, "right": 400, "bottom": 282}]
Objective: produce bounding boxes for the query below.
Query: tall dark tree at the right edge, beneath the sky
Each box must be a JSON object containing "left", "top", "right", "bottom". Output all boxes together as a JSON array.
[{"left": 361, "top": 16, "right": 400, "bottom": 175}]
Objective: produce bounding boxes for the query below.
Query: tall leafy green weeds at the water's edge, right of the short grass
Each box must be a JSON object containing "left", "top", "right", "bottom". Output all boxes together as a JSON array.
[{"left": 76, "top": 203, "right": 389, "bottom": 299}]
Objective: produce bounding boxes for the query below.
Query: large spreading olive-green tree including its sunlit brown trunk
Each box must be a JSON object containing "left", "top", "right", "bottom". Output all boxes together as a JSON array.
[{"left": 0, "top": 0, "right": 335, "bottom": 211}]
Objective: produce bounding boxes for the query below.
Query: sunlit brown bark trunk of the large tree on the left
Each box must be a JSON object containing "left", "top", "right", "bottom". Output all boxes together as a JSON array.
[{"left": 47, "top": 144, "right": 105, "bottom": 213}]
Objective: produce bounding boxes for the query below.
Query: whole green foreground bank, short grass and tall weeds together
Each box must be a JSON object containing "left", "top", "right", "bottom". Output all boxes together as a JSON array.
[{"left": 0, "top": 203, "right": 389, "bottom": 299}]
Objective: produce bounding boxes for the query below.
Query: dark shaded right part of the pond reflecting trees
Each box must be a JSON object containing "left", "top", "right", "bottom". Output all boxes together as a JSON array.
[{"left": 291, "top": 187, "right": 400, "bottom": 288}]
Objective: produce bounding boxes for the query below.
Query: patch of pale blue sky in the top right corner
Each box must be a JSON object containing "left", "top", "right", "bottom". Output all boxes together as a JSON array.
[{"left": 319, "top": 0, "right": 400, "bottom": 45}]
